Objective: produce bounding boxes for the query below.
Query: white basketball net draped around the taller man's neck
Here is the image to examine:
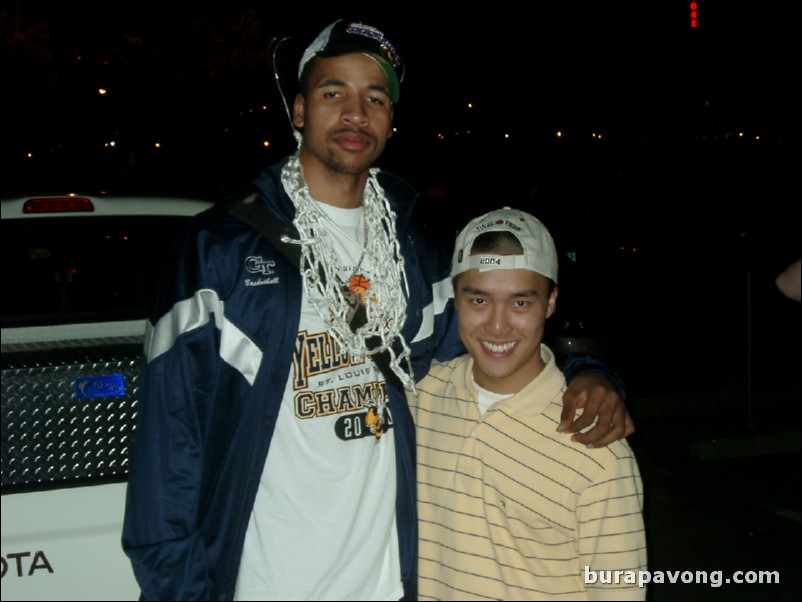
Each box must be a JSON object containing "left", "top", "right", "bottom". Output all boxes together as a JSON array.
[{"left": 281, "top": 152, "right": 415, "bottom": 392}]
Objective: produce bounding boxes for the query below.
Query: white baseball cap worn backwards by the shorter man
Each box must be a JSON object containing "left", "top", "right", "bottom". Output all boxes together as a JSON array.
[{"left": 451, "top": 207, "right": 557, "bottom": 283}]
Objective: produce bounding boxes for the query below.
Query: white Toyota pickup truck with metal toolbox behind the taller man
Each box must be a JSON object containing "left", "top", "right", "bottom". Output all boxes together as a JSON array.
[{"left": 1, "top": 195, "right": 212, "bottom": 601}]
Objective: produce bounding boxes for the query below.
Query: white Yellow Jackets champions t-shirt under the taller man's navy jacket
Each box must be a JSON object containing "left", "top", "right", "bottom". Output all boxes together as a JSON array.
[{"left": 235, "top": 203, "right": 403, "bottom": 600}]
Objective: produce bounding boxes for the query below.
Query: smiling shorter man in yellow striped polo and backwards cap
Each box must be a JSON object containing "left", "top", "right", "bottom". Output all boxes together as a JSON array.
[{"left": 410, "top": 207, "right": 646, "bottom": 600}]
